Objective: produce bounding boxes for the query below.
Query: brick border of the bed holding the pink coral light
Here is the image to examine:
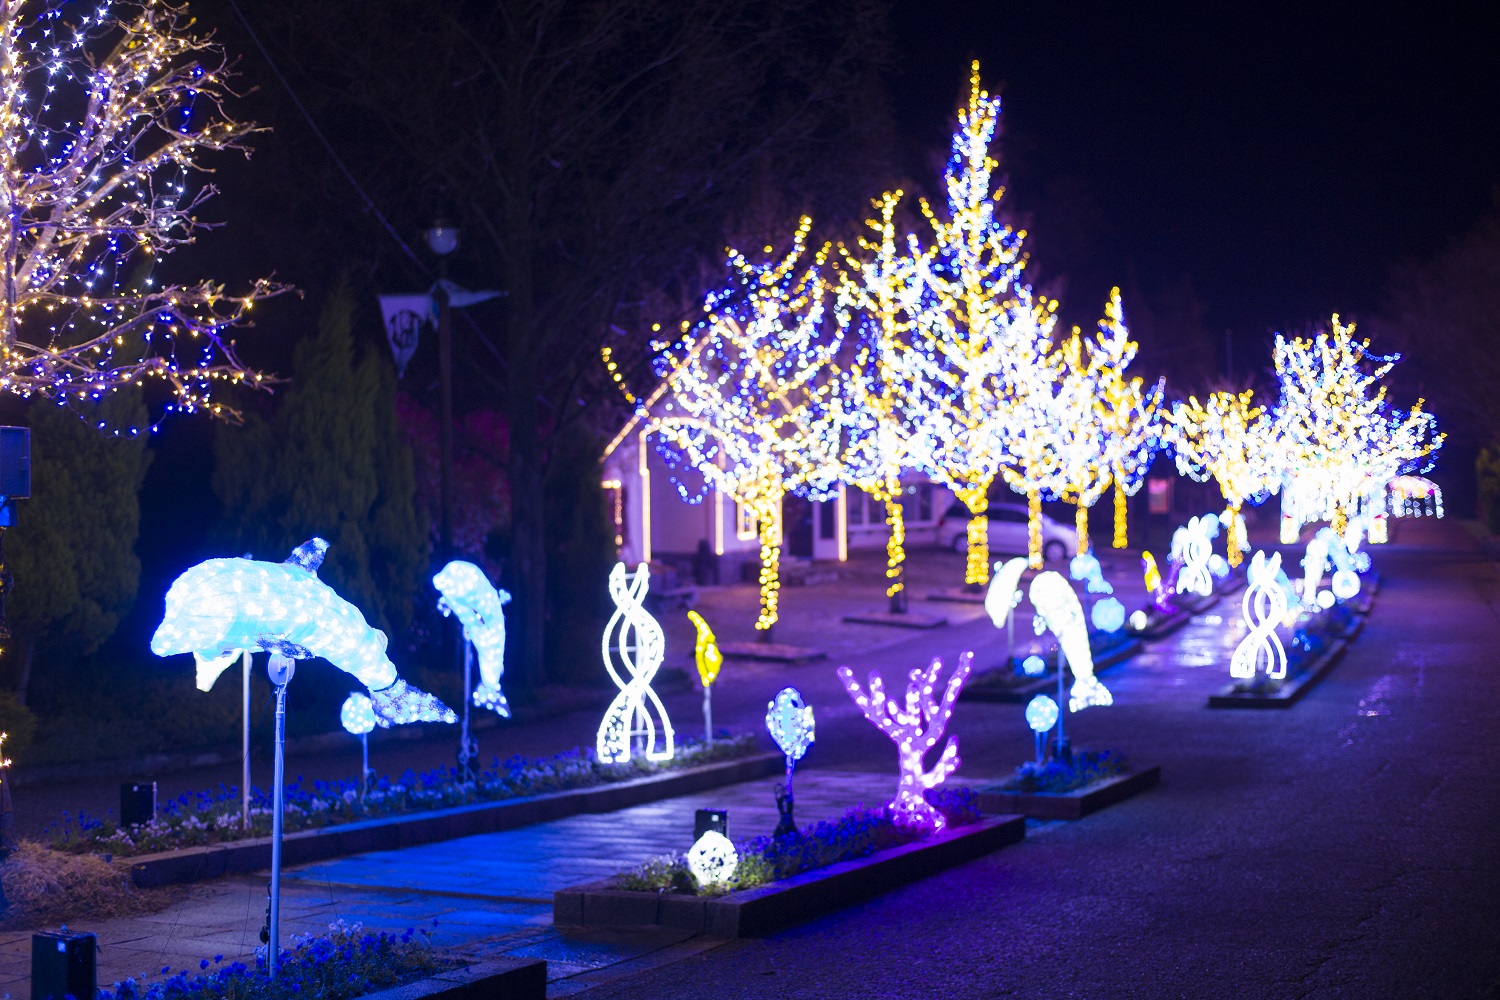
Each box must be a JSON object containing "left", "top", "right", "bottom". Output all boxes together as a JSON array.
[{"left": 552, "top": 816, "right": 1026, "bottom": 937}]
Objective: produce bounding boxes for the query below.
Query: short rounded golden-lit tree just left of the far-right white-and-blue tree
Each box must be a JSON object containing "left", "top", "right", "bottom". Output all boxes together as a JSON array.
[{"left": 1167, "top": 388, "right": 1281, "bottom": 567}]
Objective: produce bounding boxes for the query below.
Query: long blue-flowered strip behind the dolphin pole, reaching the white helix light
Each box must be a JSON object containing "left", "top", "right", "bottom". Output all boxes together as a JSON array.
[{"left": 51, "top": 735, "right": 756, "bottom": 858}]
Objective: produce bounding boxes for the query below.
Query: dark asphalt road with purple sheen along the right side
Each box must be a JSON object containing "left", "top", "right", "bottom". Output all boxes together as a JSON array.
[{"left": 576, "top": 523, "right": 1500, "bottom": 1000}]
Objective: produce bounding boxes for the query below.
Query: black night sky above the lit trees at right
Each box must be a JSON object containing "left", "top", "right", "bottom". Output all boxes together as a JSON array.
[{"left": 891, "top": 0, "right": 1500, "bottom": 349}]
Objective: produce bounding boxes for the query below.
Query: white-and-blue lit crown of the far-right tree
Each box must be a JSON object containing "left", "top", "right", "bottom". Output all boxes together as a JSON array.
[{"left": 1274, "top": 313, "right": 1443, "bottom": 534}]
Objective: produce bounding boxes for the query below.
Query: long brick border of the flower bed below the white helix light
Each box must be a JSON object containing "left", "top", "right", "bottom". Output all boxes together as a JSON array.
[{"left": 116, "top": 753, "right": 785, "bottom": 888}]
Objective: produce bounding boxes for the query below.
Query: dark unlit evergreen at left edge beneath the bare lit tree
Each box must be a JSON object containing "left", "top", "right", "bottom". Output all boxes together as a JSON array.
[{"left": 6, "top": 393, "right": 150, "bottom": 703}]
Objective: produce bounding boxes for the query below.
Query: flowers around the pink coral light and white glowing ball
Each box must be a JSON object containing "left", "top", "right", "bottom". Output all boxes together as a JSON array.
[{"left": 615, "top": 789, "right": 980, "bottom": 895}]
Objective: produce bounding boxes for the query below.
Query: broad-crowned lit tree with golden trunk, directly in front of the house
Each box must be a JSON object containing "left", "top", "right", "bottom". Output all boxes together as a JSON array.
[{"left": 650, "top": 217, "right": 848, "bottom": 637}]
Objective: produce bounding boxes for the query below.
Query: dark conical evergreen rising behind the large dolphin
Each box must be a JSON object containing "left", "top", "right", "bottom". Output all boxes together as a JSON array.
[{"left": 213, "top": 283, "right": 428, "bottom": 634}]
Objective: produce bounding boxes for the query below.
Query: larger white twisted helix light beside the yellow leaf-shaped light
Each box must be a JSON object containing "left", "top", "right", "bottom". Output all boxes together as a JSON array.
[{"left": 596, "top": 562, "right": 675, "bottom": 763}]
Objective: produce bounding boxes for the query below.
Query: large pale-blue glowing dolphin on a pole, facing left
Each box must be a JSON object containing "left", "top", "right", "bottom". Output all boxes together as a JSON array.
[{"left": 152, "top": 538, "right": 458, "bottom": 727}]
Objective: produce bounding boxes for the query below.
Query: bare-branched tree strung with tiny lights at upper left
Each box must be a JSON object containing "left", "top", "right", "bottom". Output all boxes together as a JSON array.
[{"left": 0, "top": 0, "right": 285, "bottom": 418}]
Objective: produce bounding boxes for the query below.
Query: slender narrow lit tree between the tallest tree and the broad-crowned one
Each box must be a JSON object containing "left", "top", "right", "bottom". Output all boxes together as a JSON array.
[{"left": 839, "top": 190, "right": 930, "bottom": 612}]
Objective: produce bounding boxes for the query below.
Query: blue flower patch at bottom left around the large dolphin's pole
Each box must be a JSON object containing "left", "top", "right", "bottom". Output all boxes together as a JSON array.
[{"left": 99, "top": 921, "right": 459, "bottom": 1000}]
